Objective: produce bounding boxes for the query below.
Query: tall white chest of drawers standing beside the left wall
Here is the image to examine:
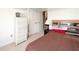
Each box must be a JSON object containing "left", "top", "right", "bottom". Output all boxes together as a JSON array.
[{"left": 15, "top": 11, "right": 27, "bottom": 45}]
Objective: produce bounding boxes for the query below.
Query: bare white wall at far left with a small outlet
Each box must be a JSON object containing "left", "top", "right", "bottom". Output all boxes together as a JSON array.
[{"left": 0, "top": 8, "right": 14, "bottom": 47}]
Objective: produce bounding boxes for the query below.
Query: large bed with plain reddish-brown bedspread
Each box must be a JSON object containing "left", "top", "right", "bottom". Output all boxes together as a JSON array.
[{"left": 25, "top": 31, "right": 79, "bottom": 51}]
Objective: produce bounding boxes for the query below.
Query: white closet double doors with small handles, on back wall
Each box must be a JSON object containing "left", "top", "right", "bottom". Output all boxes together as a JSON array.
[{"left": 29, "top": 9, "right": 41, "bottom": 35}]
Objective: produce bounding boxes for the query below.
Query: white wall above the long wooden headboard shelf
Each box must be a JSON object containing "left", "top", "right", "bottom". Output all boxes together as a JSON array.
[{"left": 48, "top": 8, "right": 79, "bottom": 20}]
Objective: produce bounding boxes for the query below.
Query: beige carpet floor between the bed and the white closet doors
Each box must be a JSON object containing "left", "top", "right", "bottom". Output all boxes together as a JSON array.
[{"left": 0, "top": 32, "right": 44, "bottom": 51}]
